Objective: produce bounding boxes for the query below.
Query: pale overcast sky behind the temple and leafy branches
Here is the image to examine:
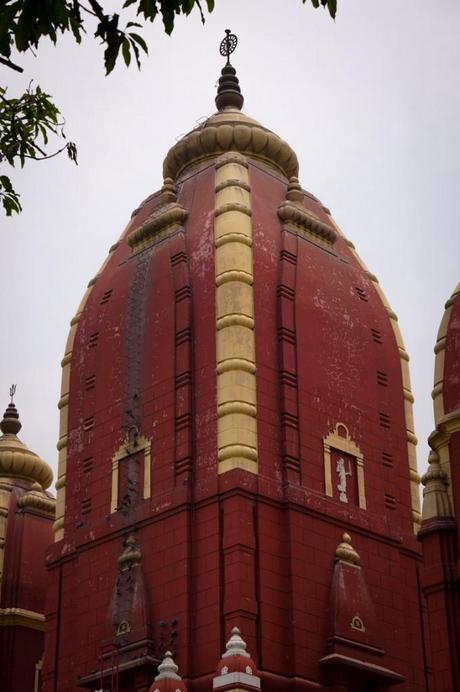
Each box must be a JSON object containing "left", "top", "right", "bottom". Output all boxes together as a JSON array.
[{"left": 0, "top": 0, "right": 460, "bottom": 486}]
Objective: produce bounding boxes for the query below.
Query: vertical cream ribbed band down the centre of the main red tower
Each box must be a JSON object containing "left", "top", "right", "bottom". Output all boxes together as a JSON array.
[{"left": 214, "top": 152, "right": 258, "bottom": 473}]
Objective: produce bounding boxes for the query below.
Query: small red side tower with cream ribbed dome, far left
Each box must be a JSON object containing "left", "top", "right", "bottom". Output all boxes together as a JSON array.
[{"left": 0, "top": 394, "right": 55, "bottom": 692}]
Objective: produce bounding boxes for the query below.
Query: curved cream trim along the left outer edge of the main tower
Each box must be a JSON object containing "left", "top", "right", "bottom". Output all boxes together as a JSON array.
[{"left": 53, "top": 230, "right": 126, "bottom": 542}]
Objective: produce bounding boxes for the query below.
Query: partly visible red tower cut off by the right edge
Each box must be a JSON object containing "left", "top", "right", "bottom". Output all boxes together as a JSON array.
[{"left": 419, "top": 285, "right": 460, "bottom": 692}]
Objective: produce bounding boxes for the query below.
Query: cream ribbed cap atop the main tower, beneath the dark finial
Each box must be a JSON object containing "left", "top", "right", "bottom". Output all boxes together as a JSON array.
[{"left": 163, "top": 108, "right": 299, "bottom": 182}]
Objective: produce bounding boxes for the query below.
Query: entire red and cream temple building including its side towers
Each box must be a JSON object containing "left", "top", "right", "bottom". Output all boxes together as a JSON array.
[{"left": 0, "top": 32, "right": 460, "bottom": 692}]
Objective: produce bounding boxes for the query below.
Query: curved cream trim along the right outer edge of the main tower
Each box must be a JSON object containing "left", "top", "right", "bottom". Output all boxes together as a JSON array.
[{"left": 331, "top": 218, "right": 421, "bottom": 533}]
